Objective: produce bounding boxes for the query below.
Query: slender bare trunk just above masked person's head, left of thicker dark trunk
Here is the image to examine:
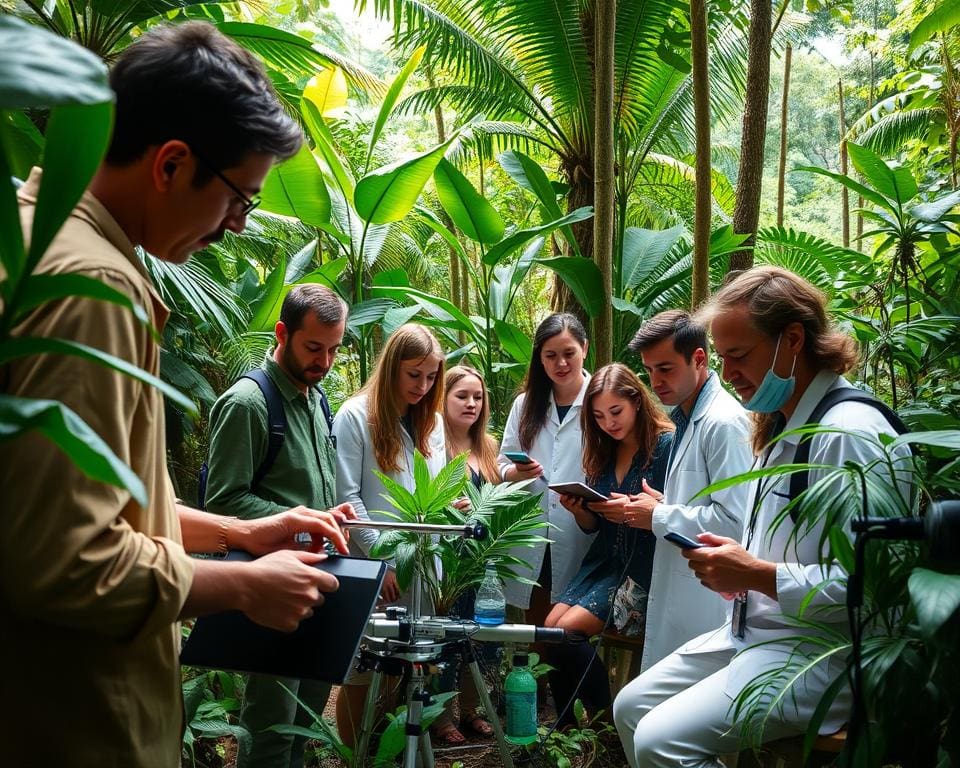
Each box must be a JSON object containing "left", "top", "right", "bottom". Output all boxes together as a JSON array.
[{"left": 690, "top": 0, "right": 713, "bottom": 309}]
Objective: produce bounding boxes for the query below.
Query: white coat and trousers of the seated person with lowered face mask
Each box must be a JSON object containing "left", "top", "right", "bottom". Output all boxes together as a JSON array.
[{"left": 614, "top": 371, "right": 910, "bottom": 766}]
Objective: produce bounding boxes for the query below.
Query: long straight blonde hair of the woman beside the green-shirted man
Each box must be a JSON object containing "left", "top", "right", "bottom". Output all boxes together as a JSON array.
[{"left": 361, "top": 323, "right": 445, "bottom": 473}]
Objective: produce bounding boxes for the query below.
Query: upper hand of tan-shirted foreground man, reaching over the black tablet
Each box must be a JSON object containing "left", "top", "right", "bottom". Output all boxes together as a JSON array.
[{"left": 233, "top": 504, "right": 357, "bottom": 555}]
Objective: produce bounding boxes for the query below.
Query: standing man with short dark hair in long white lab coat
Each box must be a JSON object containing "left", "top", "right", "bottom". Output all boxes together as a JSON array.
[{"left": 630, "top": 309, "right": 753, "bottom": 671}]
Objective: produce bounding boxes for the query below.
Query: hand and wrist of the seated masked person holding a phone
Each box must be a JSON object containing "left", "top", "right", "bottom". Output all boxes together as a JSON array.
[{"left": 681, "top": 533, "right": 777, "bottom": 600}]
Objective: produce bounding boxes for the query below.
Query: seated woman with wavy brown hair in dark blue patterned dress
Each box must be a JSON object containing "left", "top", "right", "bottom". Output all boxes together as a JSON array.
[{"left": 546, "top": 363, "right": 674, "bottom": 723}]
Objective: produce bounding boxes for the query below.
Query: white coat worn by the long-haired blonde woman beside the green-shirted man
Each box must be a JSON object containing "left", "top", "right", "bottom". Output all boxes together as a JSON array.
[{"left": 333, "top": 394, "right": 447, "bottom": 557}]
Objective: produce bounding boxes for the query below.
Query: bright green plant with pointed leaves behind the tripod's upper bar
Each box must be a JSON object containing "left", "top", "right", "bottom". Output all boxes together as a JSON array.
[{"left": 370, "top": 452, "right": 548, "bottom": 615}]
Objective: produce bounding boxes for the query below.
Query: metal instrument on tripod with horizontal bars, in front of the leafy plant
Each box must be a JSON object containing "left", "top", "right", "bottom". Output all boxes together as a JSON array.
[{"left": 342, "top": 520, "right": 566, "bottom": 768}]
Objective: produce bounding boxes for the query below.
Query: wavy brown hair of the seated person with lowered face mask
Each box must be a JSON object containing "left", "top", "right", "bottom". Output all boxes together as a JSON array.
[{"left": 697, "top": 264, "right": 858, "bottom": 455}]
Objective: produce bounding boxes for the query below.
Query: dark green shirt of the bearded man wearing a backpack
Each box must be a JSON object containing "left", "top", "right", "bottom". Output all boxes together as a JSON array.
[{"left": 206, "top": 353, "right": 337, "bottom": 520}]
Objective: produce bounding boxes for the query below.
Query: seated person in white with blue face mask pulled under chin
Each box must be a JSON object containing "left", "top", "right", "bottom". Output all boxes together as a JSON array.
[{"left": 614, "top": 267, "right": 909, "bottom": 768}]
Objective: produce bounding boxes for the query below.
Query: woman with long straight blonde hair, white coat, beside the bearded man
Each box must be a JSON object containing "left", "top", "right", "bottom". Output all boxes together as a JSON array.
[{"left": 333, "top": 323, "right": 447, "bottom": 745}]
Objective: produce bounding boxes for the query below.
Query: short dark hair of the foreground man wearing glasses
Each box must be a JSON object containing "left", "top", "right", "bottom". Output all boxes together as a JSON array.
[{"left": 106, "top": 21, "right": 303, "bottom": 178}]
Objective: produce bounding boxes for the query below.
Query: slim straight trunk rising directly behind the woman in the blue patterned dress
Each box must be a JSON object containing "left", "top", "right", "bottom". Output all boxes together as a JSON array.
[{"left": 593, "top": 0, "right": 617, "bottom": 368}]
